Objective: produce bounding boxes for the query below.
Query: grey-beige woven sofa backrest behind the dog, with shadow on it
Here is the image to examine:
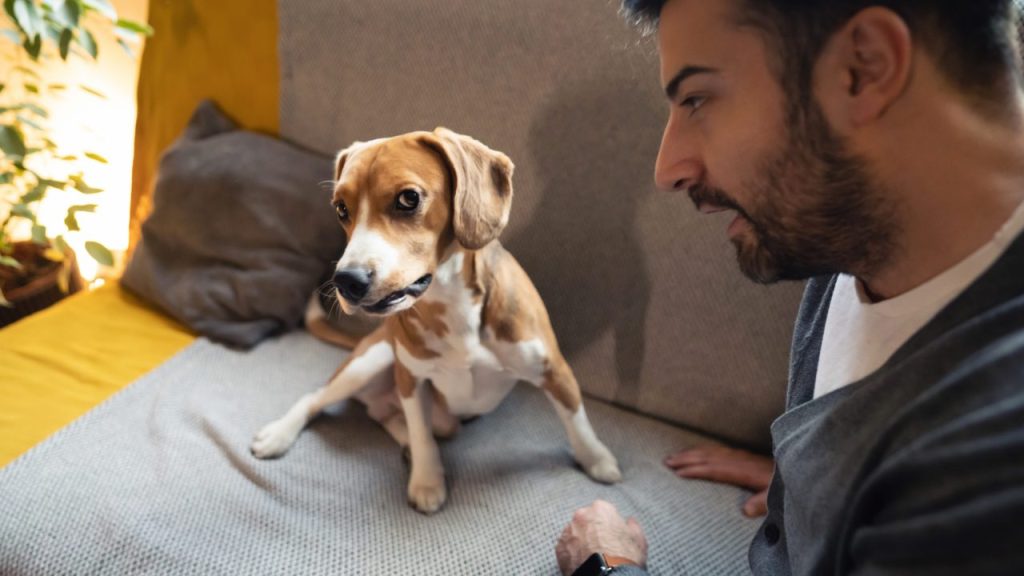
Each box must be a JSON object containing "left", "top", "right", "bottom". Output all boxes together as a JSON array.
[{"left": 279, "top": 0, "right": 800, "bottom": 449}]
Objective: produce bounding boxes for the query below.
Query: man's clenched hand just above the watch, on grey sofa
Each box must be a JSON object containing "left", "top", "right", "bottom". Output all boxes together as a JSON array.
[{"left": 555, "top": 500, "right": 647, "bottom": 575}]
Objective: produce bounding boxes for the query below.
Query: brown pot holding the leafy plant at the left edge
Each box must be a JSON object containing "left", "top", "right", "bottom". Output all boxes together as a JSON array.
[{"left": 0, "top": 242, "right": 85, "bottom": 328}]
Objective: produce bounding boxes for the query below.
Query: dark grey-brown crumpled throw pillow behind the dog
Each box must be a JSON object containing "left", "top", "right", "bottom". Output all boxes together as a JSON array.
[{"left": 121, "top": 101, "right": 345, "bottom": 347}]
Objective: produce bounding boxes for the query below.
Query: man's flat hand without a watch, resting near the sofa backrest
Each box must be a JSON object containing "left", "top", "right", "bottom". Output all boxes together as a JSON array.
[{"left": 665, "top": 445, "right": 775, "bottom": 518}]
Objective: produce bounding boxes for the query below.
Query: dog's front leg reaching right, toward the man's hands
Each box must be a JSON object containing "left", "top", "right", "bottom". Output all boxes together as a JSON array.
[{"left": 543, "top": 360, "right": 623, "bottom": 484}]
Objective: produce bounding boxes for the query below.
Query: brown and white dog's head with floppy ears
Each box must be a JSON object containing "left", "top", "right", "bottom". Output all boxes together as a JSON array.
[{"left": 332, "top": 128, "right": 513, "bottom": 315}]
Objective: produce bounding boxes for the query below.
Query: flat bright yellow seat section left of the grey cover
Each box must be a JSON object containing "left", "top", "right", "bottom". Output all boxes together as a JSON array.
[{"left": 0, "top": 284, "right": 196, "bottom": 466}]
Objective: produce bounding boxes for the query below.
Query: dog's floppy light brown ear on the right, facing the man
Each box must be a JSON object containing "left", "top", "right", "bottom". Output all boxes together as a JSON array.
[{"left": 424, "top": 128, "right": 515, "bottom": 250}]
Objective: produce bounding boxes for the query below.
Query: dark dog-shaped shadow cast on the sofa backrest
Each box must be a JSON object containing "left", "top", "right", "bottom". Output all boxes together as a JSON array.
[{"left": 508, "top": 79, "right": 664, "bottom": 403}]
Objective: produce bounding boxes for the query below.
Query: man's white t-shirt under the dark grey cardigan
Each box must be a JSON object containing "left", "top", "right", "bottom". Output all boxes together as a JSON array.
[{"left": 814, "top": 199, "right": 1024, "bottom": 398}]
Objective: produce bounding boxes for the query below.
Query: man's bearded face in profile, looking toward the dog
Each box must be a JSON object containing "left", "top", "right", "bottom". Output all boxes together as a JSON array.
[{"left": 655, "top": 0, "right": 894, "bottom": 283}]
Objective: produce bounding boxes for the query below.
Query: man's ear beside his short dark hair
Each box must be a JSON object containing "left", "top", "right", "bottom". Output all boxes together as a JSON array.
[{"left": 815, "top": 6, "right": 913, "bottom": 126}]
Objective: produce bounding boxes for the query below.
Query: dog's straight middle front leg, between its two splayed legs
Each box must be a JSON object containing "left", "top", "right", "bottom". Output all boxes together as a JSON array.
[{"left": 394, "top": 360, "right": 447, "bottom": 515}]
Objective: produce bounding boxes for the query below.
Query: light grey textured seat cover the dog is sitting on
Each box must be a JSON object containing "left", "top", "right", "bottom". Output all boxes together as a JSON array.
[{"left": 0, "top": 332, "right": 757, "bottom": 576}]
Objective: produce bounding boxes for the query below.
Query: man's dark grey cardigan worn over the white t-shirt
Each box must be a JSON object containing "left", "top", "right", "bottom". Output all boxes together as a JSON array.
[{"left": 751, "top": 230, "right": 1024, "bottom": 576}]
